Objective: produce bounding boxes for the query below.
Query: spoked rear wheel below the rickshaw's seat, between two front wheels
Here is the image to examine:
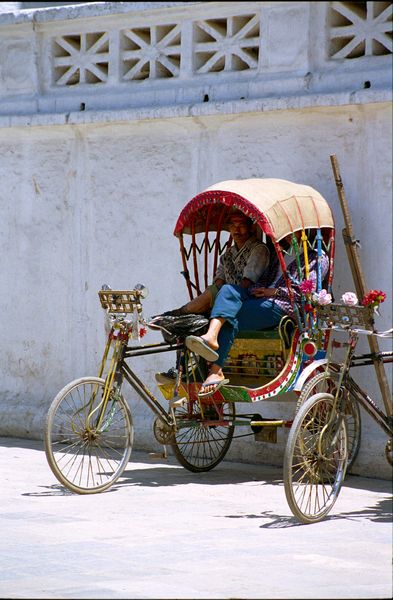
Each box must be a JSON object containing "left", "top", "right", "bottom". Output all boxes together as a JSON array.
[{"left": 172, "top": 400, "right": 236, "bottom": 473}]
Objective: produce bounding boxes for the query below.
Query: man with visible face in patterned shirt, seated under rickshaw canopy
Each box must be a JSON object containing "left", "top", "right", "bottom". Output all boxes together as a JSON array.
[{"left": 164, "top": 210, "right": 270, "bottom": 316}]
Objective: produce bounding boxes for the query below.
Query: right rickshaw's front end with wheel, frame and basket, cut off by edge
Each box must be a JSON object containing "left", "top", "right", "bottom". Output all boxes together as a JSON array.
[{"left": 284, "top": 304, "right": 393, "bottom": 523}]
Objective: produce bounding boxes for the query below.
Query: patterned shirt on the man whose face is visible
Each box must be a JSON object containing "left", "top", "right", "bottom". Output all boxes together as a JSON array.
[{"left": 214, "top": 237, "right": 270, "bottom": 285}]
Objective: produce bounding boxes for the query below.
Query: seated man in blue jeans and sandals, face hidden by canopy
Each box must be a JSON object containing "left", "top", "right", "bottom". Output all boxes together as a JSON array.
[{"left": 186, "top": 232, "right": 329, "bottom": 396}]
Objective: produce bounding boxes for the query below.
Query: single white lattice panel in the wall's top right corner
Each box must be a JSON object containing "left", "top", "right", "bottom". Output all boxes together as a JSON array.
[{"left": 329, "top": 2, "right": 392, "bottom": 59}]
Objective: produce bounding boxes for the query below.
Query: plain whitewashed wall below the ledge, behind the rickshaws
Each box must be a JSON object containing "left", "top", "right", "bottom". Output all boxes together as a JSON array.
[{"left": 0, "top": 104, "right": 392, "bottom": 474}]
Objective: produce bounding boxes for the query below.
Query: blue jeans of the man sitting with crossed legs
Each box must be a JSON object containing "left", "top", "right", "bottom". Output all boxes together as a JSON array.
[{"left": 210, "top": 284, "right": 285, "bottom": 367}]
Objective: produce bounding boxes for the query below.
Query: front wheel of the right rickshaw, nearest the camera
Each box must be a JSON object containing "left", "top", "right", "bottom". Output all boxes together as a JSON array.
[{"left": 284, "top": 393, "right": 347, "bottom": 523}]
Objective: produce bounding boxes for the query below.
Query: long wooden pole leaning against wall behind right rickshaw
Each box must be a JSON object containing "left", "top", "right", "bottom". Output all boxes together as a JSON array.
[{"left": 330, "top": 154, "right": 393, "bottom": 417}]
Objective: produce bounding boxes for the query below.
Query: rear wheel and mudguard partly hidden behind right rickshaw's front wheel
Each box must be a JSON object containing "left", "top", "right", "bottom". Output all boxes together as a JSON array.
[{"left": 296, "top": 371, "right": 362, "bottom": 472}]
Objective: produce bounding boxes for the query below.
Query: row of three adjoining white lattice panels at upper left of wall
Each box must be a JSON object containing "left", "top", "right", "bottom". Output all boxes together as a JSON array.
[{"left": 52, "top": 14, "right": 260, "bottom": 86}]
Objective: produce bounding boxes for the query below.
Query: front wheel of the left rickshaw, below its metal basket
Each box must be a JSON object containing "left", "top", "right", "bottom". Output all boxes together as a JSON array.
[{"left": 44, "top": 377, "right": 133, "bottom": 494}]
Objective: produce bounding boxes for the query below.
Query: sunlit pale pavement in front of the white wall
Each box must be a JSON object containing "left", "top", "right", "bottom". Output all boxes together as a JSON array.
[{"left": 0, "top": 438, "right": 392, "bottom": 600}]
